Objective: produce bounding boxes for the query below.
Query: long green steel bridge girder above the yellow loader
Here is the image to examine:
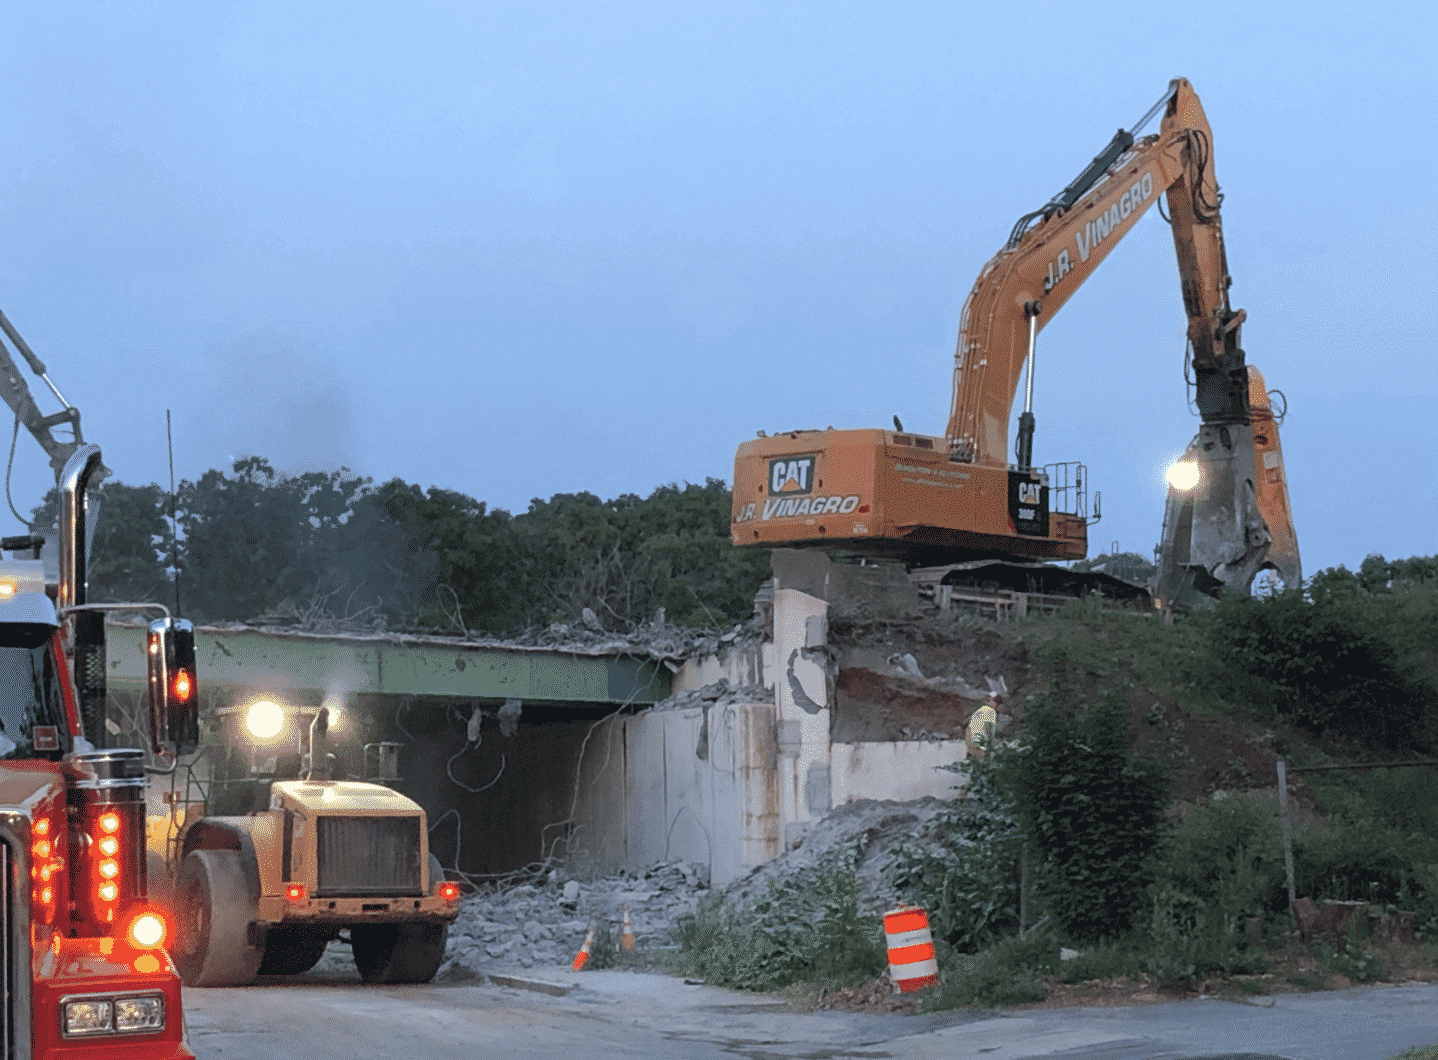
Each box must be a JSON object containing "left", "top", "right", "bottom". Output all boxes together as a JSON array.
[{"left": 106, "top": 624, "right": 670, "bottom": 706}]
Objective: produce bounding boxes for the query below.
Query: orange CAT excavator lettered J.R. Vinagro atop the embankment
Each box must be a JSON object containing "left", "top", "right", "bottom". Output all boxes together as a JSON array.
[{"left": 731, "top": 79, "right": 1300, "bottom": 601}]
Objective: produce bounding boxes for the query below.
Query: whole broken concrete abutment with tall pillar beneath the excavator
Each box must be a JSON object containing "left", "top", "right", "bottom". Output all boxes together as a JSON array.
[{"left": 560, "top": 549, "right": 988, "bottom": 886}]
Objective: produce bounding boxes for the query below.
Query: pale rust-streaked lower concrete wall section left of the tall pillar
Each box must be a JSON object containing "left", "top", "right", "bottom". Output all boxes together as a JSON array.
[{"left": 571, "top": 702, "right": 779, "bottom": 886}]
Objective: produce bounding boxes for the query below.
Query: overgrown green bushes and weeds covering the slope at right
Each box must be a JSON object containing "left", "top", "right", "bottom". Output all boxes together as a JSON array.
[{"left": 675, "top": 558, "right": 1438, "bottom": 1007}]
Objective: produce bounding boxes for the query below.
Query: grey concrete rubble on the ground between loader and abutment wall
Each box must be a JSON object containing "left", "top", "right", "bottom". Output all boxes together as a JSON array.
[{"left": 437, "top": 862, "right": 709, "bottom": 981}]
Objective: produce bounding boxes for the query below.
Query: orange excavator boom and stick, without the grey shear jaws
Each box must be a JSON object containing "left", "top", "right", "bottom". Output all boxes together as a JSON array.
[{"left": 948, "top": 78, "right": 1248, "bottom": 467}]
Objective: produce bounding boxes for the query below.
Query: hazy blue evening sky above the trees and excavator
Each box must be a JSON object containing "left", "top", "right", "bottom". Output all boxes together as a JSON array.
[{"left": 0, "top": 0, "right": 1438, "bottom": 574}]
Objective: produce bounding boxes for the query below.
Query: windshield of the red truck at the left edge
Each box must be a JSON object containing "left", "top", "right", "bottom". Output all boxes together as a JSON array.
[{"left": 0, "top": 623, "right": 73, "bottom": 761}]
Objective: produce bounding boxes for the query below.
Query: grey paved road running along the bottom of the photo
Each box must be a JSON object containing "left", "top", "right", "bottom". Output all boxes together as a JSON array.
[{"left": 186, "top": 969, "right": 1438, "bottom": 1060}]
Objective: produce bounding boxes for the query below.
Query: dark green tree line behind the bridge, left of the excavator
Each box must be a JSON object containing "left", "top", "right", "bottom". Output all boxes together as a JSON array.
[{"left": 32, "top": 456, "right": 768, "bottom": 633}]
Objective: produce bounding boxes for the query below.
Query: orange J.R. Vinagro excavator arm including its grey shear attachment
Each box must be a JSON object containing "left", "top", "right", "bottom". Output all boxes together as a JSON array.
[{"left": 948, "top": 78, "right": 1301, "bottom": 606}]
